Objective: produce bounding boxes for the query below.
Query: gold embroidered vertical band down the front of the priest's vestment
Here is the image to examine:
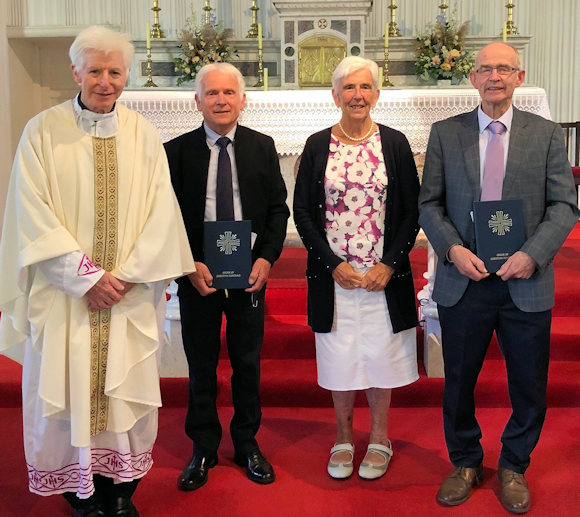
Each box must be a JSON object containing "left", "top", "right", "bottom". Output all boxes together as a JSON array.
[{"left": 89, "top": 137, "right": 118, "bottom": 435}]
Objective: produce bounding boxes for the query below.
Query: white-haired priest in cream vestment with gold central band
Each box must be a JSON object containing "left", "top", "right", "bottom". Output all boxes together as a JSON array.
[{"left": 0, "top": 27, "right": 195, "bottom": 517}]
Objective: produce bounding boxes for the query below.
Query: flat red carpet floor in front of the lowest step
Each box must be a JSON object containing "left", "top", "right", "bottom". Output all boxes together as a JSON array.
[{"left": 0, "top": 407, "right": 580, "bottom": 517}]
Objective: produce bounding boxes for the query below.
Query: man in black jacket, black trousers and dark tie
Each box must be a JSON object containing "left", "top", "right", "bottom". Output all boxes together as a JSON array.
[{"left": 165, "top": 63, "right": 289, "bottom": 491}]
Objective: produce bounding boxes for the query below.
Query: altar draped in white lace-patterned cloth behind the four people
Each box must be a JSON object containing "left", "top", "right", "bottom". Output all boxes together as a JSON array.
[{"left": 119, "top": 86, "right": 551, "bottom": 377}]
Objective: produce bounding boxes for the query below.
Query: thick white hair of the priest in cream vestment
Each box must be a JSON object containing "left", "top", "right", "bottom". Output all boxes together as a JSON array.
[{"left": 68, "top": 25, "right": 135, "bottom": 70}]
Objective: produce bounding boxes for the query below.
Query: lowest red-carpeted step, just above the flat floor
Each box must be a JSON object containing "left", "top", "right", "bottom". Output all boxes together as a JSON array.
[{"left": 161, "top": 359, "right": 580, "bottom": 407}]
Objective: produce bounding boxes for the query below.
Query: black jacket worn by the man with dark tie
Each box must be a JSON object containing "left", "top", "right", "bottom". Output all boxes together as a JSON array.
[{"left": 165, "top": 125, "right": 290, "bottom": 289}]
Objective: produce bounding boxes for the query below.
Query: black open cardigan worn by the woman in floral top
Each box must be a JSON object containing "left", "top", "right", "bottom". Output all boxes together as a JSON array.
[{"left": 294, "top": 124, "right": 419, "bottom": 332}]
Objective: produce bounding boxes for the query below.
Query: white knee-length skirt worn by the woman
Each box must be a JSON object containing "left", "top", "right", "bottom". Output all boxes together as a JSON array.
[{"left": 315, "top": 282, "right": 419, "bottom": 391}]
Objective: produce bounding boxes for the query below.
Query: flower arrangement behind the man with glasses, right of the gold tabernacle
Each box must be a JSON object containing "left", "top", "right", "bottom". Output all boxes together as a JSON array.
[{"left": 415, "top": 11, "right": 473, "bottom": 83}]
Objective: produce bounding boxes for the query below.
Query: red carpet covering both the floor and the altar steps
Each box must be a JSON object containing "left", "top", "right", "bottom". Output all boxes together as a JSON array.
[{"left": 0, "top": 225, "right": 580, "bottom": 517}]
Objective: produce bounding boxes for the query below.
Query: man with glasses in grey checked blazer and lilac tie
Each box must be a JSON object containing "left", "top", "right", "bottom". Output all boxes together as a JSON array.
[{"left": 419, "top": 42, "right": 578, "bottom": 513}]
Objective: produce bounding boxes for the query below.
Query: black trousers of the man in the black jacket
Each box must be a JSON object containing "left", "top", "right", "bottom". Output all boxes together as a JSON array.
[{"left": 179, "top": 287, "right": 266, "bottom": 454}]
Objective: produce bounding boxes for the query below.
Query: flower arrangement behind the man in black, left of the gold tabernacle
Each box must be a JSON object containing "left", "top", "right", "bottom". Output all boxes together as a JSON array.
[{"left": 174, "top": 13, "right": 238, "bottom": 86}]
